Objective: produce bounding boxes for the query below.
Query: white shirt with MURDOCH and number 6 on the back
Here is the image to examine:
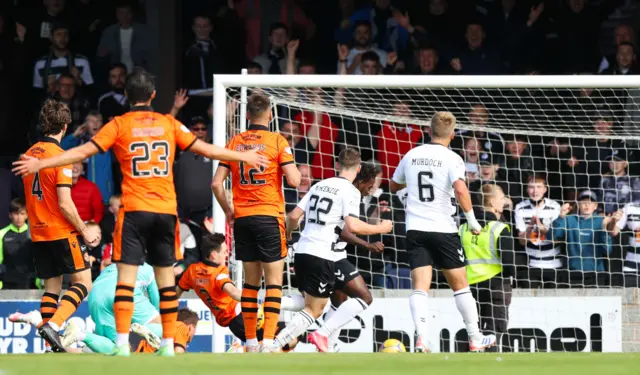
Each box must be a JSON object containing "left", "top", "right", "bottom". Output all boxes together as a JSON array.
[{"left": 393, "top": 143, "right": 465, "bottom": 233}]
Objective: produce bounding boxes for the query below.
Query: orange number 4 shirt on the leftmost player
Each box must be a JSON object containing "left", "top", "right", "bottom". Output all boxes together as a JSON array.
[{"left": 22, "top": 137, "right": 78, "bottom": 242}]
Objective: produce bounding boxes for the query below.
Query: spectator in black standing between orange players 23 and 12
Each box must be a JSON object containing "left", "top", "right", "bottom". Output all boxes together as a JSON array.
[{"left": 173, "top": 117, "right": 213, "bottom": 228}]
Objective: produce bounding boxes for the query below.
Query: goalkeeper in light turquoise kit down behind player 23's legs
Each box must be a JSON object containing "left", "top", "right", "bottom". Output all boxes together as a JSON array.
[{"left": 9, "top": 264, "right": 162, "bottom": 354}]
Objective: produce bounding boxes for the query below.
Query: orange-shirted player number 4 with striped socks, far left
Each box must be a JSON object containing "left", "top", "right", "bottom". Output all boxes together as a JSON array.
[{"left": 23, "top": 99, "right": 100, "bottom": 352}]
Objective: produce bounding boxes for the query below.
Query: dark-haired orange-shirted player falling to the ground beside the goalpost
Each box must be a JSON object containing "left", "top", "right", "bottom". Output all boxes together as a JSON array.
[{"left": 177, "top": 233, "right": 297, "bottom": 349}]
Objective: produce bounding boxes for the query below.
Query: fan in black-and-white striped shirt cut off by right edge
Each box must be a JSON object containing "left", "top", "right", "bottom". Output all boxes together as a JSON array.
[{"left": 614, "top": 202, "right": 640, "bottom": 288}]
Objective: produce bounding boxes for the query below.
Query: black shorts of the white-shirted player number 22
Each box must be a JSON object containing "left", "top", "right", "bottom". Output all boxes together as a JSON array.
[{"left": 294, "top": 254, "right": 336, "bottom": 298}]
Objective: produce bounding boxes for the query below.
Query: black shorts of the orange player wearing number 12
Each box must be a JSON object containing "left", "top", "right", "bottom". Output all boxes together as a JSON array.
[{"left": 233, "top": 215, "right": 287, "bottom": 263}]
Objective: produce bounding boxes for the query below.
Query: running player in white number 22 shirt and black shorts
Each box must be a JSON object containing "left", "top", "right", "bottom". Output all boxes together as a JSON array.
[{"left": 268, "top": 148, "right": 392, "bottom": 351}]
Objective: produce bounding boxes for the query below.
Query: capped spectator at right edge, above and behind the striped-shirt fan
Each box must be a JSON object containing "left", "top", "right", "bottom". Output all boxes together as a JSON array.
[{"left": 600, "top": 148, "right": 640, "bottom": 214}]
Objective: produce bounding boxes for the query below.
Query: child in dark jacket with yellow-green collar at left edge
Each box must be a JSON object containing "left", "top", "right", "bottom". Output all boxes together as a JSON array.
[{"left": 0, "top": 198, "right": 35, "bottom": 289}]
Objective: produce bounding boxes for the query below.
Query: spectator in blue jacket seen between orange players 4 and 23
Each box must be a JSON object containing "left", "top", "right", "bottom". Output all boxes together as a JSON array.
[{"left": 61, "top": 111, "right": 115, "bottom": 205}]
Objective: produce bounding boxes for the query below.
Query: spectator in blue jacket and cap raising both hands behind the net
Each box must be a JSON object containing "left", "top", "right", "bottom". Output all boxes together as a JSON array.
[{"left": 548, "top": 190, "right": 621, "bottom": 286}]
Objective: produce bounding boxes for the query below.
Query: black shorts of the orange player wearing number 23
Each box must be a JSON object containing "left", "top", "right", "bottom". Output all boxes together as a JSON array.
[{"left": 113, "top": 209, "right": 182, "bottom": 267}]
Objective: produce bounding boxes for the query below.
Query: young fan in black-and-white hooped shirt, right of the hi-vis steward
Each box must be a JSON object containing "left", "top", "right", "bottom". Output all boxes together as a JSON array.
[{"left": 514, "top": 174, "right": 562, "bottom": 288}]
